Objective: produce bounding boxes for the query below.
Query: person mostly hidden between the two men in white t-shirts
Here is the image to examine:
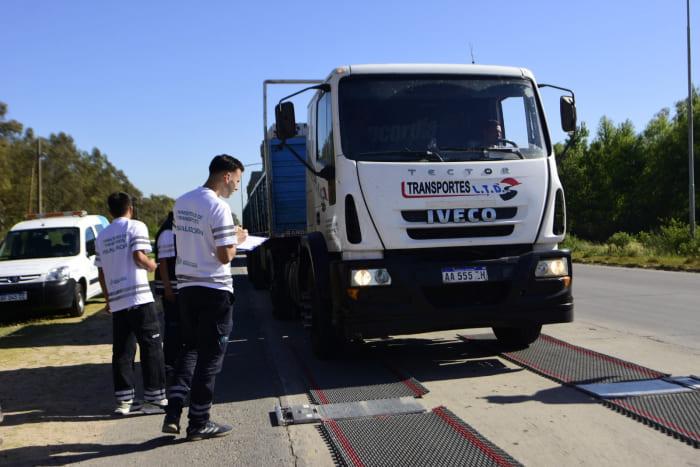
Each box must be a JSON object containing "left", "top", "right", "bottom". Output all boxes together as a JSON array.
[{"left": 153, "top": 211, "right": 182, "bottom": 385}]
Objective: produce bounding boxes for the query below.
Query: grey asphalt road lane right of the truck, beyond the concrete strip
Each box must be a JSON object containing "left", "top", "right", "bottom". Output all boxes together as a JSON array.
[{"left": 574, "top": 264, "right": 700, "bottom": 349}]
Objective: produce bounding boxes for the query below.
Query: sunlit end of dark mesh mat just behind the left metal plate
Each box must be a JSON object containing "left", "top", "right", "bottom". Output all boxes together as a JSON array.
[{"left": 309, "top": 378, "right": 428, "bottom": 404}]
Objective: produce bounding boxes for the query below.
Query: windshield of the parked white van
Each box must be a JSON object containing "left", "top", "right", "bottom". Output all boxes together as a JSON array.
[{"left": 0, "top": 227, "right": 80, "bottom": 261}]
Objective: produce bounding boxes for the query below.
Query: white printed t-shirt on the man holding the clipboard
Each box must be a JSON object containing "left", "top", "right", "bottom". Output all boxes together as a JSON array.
[{"left": 173, "top": 187, "right": 236, "bottom": 293}]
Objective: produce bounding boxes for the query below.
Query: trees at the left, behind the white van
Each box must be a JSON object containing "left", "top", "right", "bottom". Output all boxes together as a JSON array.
[{"left": 0, "top": 102, "right": 174, "bottom": 236}]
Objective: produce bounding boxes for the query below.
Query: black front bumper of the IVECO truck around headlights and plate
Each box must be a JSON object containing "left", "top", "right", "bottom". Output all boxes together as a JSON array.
[{"left": 331, "top": 249, "right": 573, "bottom": 337}]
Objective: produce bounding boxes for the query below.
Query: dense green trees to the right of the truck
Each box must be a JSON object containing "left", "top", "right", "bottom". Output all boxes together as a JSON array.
[{"left": 555, "top": 90, "right": 700, "bottom": 241}]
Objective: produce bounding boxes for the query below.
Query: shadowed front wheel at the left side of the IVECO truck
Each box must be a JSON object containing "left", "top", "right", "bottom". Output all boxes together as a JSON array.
[{"left": 307, "top": 268, "right": 345, "bottom": 360}]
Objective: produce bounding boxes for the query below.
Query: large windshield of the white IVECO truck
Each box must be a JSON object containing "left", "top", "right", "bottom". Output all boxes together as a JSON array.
[{"left": 338, "top": 75, "right": 547, "bottom": 162}]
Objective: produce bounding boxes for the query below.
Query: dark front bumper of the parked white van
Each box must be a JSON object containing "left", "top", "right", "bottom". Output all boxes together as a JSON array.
[{"left": 0, "top": 279, "right": 75, "bottom": 311}]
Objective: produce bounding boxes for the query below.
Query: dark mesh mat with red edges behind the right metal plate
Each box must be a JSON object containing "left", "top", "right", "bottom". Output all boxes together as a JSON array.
[{"left": 460, "top": 334, "right": 668, "bottom": 385}]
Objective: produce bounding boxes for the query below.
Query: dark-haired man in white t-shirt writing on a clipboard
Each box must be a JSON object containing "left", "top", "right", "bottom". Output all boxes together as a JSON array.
[{"left": 163, "top": 154, "right": 248, "bottom": 441}]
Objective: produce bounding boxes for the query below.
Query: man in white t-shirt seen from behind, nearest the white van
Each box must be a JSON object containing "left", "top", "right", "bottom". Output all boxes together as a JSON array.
[{"left": 95, "top": 192, "right": 168, "bottom": 415}]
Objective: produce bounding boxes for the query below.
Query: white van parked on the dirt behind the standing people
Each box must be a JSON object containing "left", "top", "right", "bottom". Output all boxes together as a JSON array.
[{"left": 0, "top": 211, "right": 109, "bottom": 316}]
